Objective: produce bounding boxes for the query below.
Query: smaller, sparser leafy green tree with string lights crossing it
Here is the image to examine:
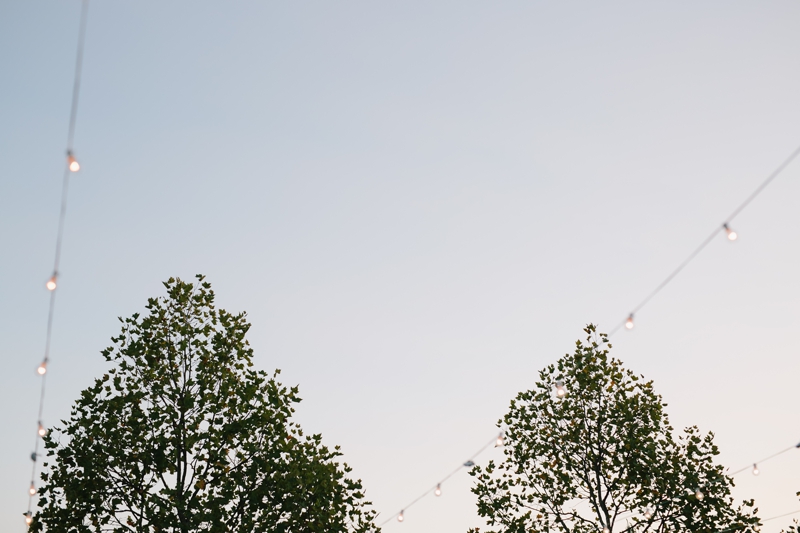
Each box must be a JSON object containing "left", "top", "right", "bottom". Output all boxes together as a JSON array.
[{"left": 471, "top": 325, "right": 759, "bottom": 533}]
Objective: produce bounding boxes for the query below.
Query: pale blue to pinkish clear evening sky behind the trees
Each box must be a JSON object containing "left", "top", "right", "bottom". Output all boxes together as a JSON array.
[{"left": 0, "top": 0, "right": 800, "bottom": 533}]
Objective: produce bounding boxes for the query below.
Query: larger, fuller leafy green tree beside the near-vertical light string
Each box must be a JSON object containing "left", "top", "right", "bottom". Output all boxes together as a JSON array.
[{"left": 31, "top": 276, "right": 375, "bottom": 533}]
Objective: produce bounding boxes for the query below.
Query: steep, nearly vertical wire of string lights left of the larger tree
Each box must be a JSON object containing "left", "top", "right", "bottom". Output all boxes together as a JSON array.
[{"left": 25, "top": 0, "right": 89, "bottom": 524}]
